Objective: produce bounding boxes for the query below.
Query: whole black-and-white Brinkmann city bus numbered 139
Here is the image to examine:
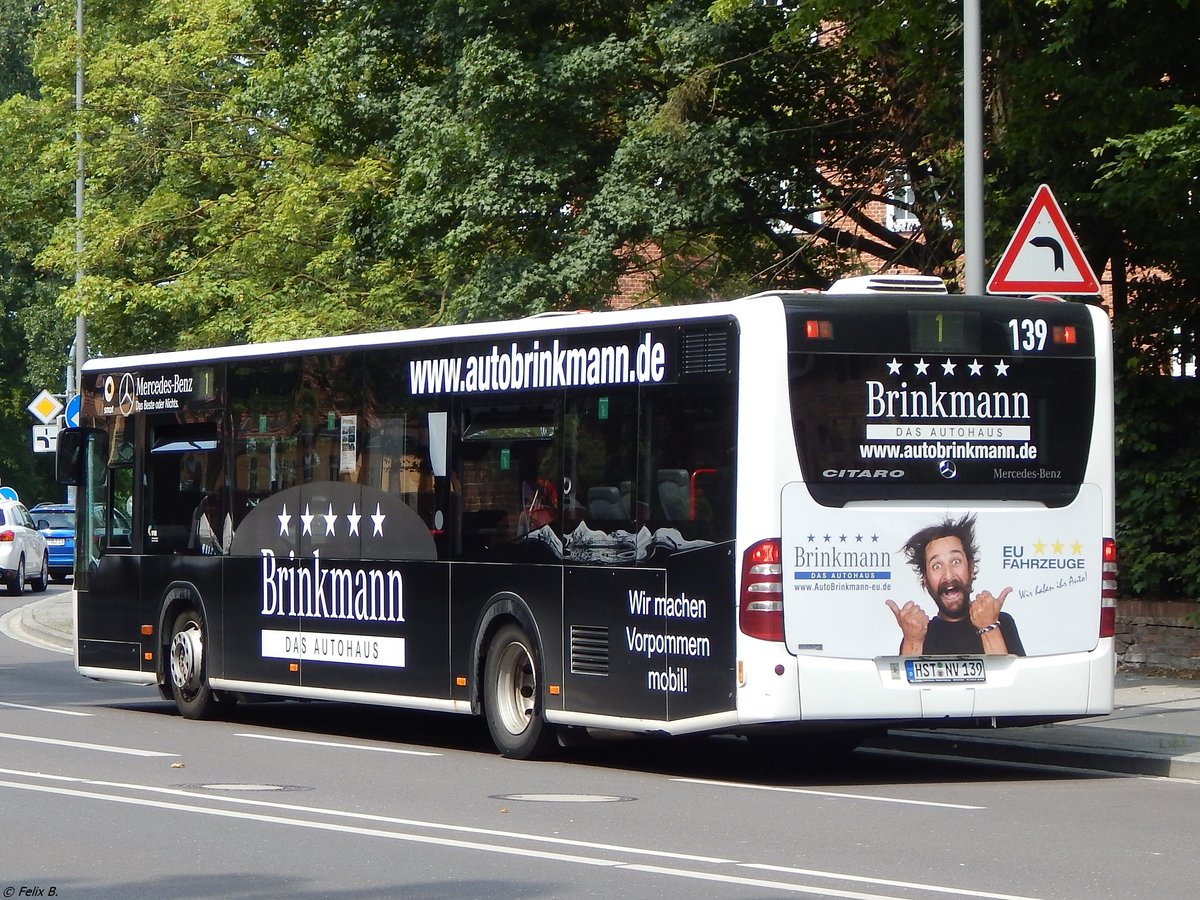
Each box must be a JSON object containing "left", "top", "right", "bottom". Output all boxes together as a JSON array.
[{"left": 58, "top": 278, "right": 1116, "bottom": 758}]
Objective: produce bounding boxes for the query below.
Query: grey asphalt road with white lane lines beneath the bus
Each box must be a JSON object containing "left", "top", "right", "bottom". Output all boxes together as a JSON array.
[{"left": 0, "top": 595, "right": 1200, "bottom": 900}]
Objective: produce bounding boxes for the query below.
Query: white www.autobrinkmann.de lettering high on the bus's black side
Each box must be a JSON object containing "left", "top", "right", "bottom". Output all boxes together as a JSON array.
[{"left": 408, "top": 331, "right": 667, "bottom": 395}]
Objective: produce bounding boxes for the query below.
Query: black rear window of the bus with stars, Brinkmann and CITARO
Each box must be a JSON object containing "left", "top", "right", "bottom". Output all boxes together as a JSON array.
[{"left": 788, "top": 299, "right": 1096, "bottom": 506}]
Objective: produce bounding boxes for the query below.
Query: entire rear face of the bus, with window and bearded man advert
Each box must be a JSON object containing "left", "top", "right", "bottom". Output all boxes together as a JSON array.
[{"left": 743, "top": 294, "right": 1115, "bottom": 726}]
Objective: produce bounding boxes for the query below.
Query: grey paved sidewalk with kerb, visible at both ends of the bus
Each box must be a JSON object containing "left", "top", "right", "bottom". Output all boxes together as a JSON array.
[{"left": 9, "top": 593, "right": 1200, "bottom": 780}]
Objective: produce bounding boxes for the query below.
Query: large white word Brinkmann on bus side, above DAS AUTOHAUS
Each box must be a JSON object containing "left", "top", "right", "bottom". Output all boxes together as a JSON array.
[{"left": 259, "top": 550, "right": 404, "bottom": 622}]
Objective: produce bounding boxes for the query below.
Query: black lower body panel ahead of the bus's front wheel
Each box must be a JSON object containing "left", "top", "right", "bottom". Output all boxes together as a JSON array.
[{"left": 76, "top": 556, "right": 143, "bottom": 672}]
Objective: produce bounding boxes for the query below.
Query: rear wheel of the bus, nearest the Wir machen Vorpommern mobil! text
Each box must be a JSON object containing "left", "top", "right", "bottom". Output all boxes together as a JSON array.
[{"left": 484, "top": 624, "right": 556, "bottom": 760}]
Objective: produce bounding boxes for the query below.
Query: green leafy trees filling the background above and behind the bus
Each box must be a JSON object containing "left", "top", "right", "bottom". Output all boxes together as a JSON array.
[{"left": 0, "top": 0, "right": 1200, "bottom": 595}]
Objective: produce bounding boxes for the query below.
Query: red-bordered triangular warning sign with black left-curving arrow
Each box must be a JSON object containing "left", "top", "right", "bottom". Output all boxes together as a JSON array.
[{"left": 988, "top": 185, "right": 1100, "bottom": 294}]
